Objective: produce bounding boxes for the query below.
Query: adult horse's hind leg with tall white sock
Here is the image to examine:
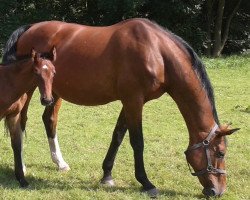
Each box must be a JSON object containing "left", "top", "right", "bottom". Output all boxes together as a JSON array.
[{"left": 43, "top": 94, "right": 70, "bottom": 171}]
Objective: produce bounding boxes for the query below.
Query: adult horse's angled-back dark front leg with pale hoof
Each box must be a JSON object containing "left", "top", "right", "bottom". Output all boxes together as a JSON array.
[{"left": 101, "top": 109, "right": 127, "bottom": 186}]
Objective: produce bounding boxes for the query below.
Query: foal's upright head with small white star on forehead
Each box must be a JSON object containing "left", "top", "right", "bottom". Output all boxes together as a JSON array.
[{"left": 31, "top": 47, "right": 56, "bottom": 106}]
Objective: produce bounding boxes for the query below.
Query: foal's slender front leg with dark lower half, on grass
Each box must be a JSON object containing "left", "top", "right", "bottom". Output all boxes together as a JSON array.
[{"left": 6, "top": 113, "right": 29, "bottom": 187}]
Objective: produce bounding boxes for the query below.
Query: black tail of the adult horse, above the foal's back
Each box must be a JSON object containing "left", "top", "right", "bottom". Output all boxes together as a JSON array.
[{"left": 2, "top": 25, "right": 32, "bottom": 64}]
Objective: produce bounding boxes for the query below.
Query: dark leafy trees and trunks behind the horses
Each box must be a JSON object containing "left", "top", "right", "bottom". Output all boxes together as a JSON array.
[{"left": 0, "top": 0, "right": 250, "bottom": 57}]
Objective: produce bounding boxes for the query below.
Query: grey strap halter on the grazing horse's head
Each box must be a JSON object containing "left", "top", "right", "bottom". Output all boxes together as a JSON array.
[{"left": 184, "top": 124, "right": 226, "bottom": 176}]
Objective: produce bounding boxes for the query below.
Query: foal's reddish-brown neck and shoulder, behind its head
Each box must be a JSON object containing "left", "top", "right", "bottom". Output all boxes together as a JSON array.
[{"left": 0, "top": 61, "right": 34, "bottom": 107}]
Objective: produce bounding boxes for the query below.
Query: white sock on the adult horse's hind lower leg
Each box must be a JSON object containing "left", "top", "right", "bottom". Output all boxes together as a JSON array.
[{"left": 48, "top": 134, "right": 70, "bottom": 171}]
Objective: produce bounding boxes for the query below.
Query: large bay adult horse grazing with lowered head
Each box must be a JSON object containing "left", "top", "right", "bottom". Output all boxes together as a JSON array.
[{"left": 3, "top": 19, "right": 238, "bottom": 197}]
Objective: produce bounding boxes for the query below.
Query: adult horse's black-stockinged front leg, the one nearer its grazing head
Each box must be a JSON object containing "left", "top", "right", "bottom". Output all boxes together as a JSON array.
[{"left": 123, "top": 98, "right": 158, "bottom": 197}]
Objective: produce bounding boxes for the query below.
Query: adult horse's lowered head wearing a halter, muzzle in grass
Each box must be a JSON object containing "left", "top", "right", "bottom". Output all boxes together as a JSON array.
[{"left": 185, "top": 124, "right": 239, "bottom": 196}]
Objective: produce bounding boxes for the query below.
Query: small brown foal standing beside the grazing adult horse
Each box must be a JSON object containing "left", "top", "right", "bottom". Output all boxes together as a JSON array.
[{"left": 0, "top": 49, "right": 55, "bottom": 186}]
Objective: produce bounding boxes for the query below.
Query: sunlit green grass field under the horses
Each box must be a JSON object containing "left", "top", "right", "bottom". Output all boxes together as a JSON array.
[{"left": 0, "top": 56, "right": 250, "bottom": 200}]
